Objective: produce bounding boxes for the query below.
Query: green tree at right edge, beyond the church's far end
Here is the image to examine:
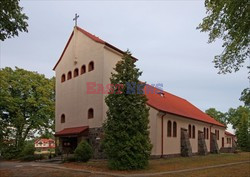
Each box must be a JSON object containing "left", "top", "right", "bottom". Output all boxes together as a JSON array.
[{"left": 227, "top": 106, "right": 250, "bottom": 151}]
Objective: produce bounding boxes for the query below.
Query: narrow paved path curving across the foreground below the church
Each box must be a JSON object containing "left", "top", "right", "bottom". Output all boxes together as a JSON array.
[{"left": 0, "top": 161, "right": 250, "bottom": 177}]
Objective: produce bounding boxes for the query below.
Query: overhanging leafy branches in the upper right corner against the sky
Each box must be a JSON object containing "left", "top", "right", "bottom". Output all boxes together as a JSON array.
[{"left": 197, "top": 0, "right": 250, "bottom": 73}]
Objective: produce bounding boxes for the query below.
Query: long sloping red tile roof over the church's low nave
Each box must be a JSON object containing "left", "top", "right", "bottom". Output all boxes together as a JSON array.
[{"left": 145, "top": 85, "right": 225, "bottom": 127}]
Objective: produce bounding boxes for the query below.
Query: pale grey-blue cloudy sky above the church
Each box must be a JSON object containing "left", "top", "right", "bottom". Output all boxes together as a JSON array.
[{"left": 0, "top": 0, "right": 249, "bottom": 132}]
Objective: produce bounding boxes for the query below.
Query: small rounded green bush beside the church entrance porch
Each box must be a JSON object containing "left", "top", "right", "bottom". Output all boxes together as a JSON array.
[{"left": 74, "top": 141, "right": 93, "bottom": 162}]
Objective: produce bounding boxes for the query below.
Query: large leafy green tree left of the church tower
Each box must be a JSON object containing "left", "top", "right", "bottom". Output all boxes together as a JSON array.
[{"left": 0, "top": 67, "right": 55, "bottom": 150}]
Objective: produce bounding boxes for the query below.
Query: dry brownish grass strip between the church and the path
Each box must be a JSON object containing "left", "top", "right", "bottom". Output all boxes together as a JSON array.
[{"left": 63, "top": 152, "right": 250, "bottom": 176}]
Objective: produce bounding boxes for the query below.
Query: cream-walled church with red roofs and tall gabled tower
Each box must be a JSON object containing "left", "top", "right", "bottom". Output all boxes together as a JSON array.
[{"left": 53, "top": 26, "right": 233, "bottom": 158}]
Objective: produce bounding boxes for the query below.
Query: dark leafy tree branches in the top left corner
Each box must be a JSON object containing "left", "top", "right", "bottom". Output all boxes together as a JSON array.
[{"left": 0, "top": 0, "right": 28, "bottom": 41}]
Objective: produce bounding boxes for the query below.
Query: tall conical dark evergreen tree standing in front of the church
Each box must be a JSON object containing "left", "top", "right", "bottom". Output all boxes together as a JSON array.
[{"left": 103, "top": 51, "right": 152, "bottom": 170}]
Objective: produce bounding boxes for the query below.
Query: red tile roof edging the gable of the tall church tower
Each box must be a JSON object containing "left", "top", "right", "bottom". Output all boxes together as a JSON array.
[{"left": 53, "top": 26, "right": 138, "bottom": 70}]
